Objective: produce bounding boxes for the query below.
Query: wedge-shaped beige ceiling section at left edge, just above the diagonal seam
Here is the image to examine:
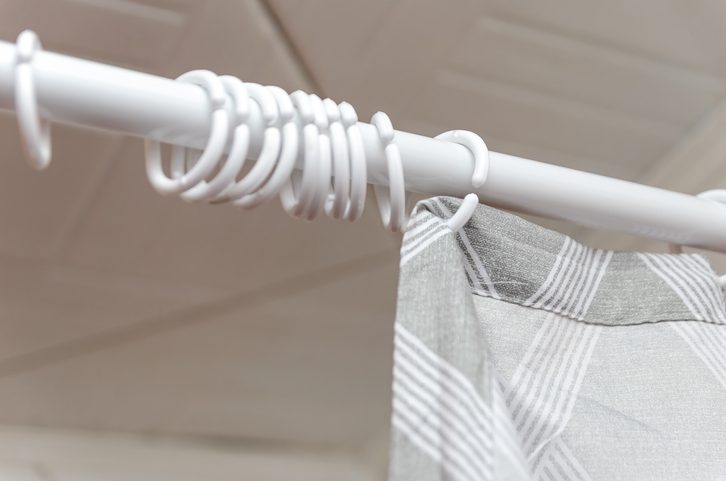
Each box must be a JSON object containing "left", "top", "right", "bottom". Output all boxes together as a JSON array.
[{"left": 0, "top": 253, "right": 221, "bottom": 362}]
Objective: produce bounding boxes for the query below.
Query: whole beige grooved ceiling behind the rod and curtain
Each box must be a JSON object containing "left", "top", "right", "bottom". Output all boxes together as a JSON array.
[{"left": 0, "top": 0, "right": 726, "bottom": 479}]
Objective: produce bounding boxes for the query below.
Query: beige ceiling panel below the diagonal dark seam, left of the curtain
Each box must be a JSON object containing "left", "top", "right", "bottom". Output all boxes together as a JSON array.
[{"left": 0, "top": 254, "right": 396, "bottom": 446}]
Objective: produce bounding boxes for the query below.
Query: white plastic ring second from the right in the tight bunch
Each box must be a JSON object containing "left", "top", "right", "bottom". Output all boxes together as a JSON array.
[{"left": 323, "top": 99, "right": 350, "bottom": 219}]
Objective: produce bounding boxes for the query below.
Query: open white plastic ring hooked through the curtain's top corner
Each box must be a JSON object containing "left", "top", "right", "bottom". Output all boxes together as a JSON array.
[{"left": 435, "top": 130, "right": 489, "bottom": 232}]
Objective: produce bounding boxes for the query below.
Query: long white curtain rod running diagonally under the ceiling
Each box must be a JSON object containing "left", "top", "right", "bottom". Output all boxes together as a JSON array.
[{"left": 0, "top": 41, "right": 726, "bottom": 252}]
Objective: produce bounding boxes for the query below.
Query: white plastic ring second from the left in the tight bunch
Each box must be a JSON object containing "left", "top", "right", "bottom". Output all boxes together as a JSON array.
[{"left": 178, "top": 75, "right": 250, "bottom": 202}]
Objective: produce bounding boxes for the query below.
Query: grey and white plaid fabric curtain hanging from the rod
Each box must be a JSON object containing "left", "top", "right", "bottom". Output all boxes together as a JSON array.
[{"left": 390, "top": 197, "right": 726, "bottom": 481}]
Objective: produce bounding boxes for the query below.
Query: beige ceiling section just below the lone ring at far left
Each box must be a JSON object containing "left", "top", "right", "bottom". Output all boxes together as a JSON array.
[{"left": 0, "top": 113, "right": 120, "bottom": 259}]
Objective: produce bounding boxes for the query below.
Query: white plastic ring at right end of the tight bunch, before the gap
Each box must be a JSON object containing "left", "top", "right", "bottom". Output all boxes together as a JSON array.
[{"left": 338, "top": 102, "right": 368, "bottom": 222}]
